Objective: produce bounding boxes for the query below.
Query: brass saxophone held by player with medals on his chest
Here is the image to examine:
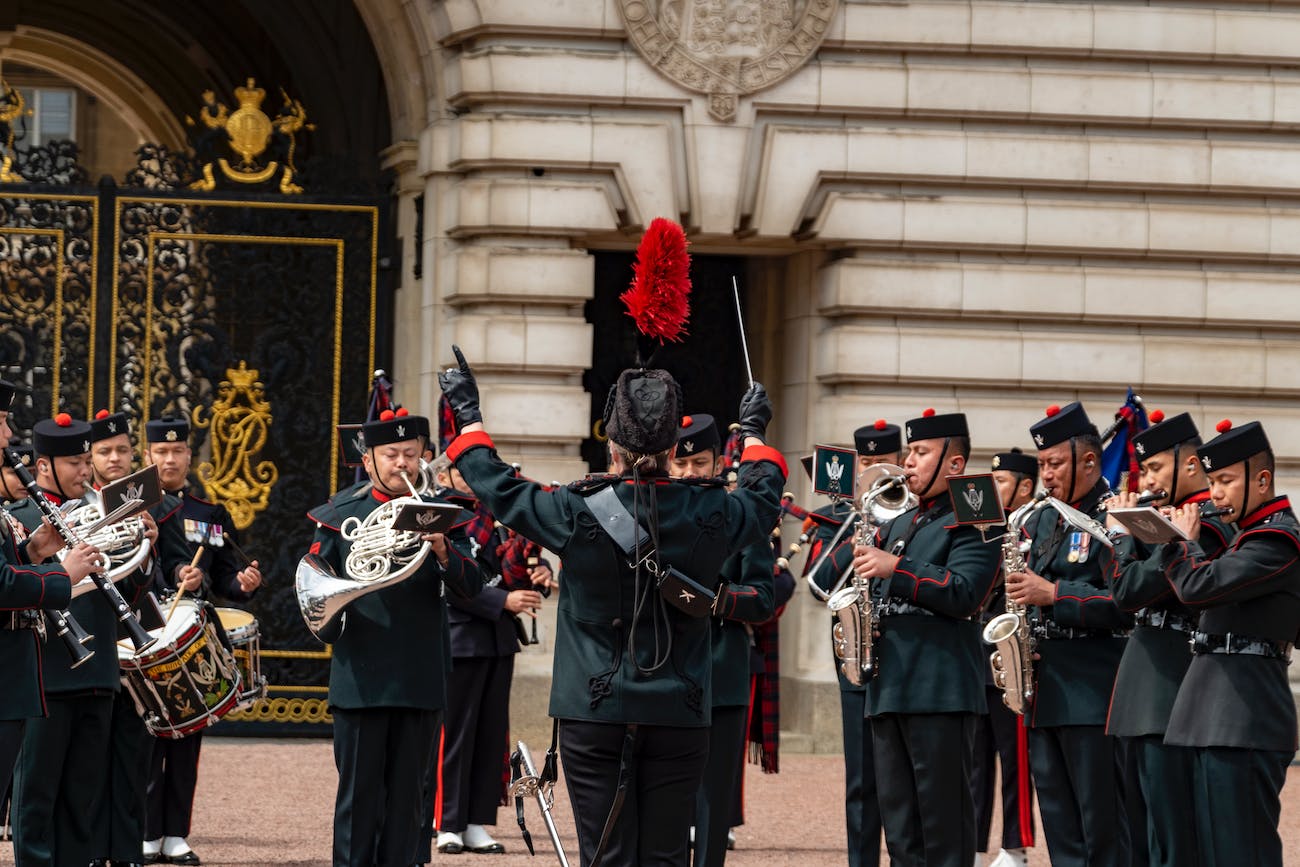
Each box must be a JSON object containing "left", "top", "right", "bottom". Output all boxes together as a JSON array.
[{"left": 984, "top": 491, "right": 1048, "bottom": 716}]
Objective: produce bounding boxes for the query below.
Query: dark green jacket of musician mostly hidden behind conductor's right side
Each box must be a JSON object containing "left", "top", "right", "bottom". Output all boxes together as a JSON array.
[{"left": 711, "top": 539, "right": 776, "bottom": 707}]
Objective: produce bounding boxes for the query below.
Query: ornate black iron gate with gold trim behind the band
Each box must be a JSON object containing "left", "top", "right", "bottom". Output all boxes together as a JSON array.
[{"left": 0, "top": 111, "right": 393, "bottom": 733}]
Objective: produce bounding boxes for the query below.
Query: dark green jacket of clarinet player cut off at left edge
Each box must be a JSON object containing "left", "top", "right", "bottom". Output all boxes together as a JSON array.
[{"left": 0, "top": 517, "right": 72, "bottom": 720}]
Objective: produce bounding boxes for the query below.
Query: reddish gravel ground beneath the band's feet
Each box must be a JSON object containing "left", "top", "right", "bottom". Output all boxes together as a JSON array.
[{"left": 0, "top": 736, "right": 1300, "bottom": 867}]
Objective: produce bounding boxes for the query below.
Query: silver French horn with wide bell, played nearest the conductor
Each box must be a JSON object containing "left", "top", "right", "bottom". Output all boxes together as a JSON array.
[{"left": 294, "top": 458, "right": 433, "bottom": 638}]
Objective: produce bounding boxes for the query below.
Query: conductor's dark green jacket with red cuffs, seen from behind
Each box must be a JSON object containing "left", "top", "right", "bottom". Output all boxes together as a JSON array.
[{"left": 447, "top": 432, "right": 785, "bottom": 727}]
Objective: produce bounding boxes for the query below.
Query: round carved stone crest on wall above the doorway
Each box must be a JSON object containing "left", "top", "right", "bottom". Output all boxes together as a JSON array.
[{"left": 619, "top": 0, "right": 839, "bottom": 121}]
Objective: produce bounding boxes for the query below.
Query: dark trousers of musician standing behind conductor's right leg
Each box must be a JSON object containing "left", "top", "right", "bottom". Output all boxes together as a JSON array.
[{"left": 692, "top": 707, "right": 749, "bottom": 867}]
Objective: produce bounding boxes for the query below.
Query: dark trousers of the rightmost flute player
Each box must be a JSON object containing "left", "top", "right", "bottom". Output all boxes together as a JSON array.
[{"left": 1193, "top": 747, "right": 1295, "bottom": 867}]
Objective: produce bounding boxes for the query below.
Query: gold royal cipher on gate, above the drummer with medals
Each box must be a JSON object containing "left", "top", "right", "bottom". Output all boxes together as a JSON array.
[{"left": 192, "top": 361, "right": 280, "bottom": 530}]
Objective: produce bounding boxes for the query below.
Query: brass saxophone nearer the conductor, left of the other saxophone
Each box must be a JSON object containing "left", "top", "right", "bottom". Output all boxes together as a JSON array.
[{"left": 826, "top": 464, "right": 918, "bottom": 686}]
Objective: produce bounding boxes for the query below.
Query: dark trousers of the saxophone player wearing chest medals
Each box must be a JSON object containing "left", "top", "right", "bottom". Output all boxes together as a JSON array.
[{"left": 1030, "top": 725, "right": 1130, "bottom": 867}]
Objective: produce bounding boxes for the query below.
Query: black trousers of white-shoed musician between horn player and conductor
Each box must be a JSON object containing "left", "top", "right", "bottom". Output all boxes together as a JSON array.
[{"left": 439, "top": 655, "right": 515, "bottom": 833}]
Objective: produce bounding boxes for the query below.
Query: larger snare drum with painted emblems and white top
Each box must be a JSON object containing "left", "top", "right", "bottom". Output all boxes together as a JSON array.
[{"left": 118, "top": 599, "right": 241, "bottom": 738}]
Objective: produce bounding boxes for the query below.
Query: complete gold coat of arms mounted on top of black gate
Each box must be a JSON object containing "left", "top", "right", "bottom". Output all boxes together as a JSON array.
[{"left": 185, "top": 78, "right": 316, "bottom": 194}]
